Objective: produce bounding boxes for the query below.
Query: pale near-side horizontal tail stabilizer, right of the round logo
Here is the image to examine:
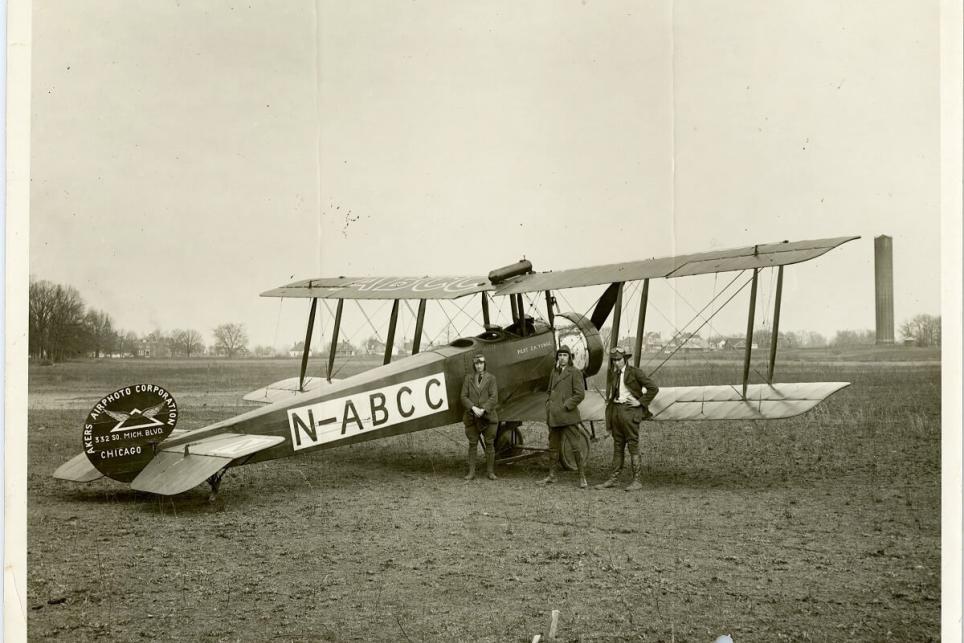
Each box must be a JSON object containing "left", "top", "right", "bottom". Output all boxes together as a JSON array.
[{"left": 131, "top": 433, "right": 284, "bottom": 496}]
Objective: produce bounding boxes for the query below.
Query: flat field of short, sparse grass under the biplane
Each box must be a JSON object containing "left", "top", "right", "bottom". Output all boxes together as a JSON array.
[{"left": 27, "top": 354, "right": 941, "bottom": 643}]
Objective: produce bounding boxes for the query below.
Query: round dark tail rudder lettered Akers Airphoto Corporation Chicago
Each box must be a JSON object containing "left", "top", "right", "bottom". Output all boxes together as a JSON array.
[{"left": 84, "top": 384, "right": 177, "bottom": 482}]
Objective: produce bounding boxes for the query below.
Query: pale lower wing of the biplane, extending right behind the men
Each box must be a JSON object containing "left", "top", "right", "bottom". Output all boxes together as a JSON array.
[{"left": 499, "top": 382, "right": 850, "bottom": 422}]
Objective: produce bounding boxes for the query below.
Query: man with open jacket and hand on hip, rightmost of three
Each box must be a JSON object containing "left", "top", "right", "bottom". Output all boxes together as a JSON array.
[{"left": 595, "top": 348, "right": 659, "bottom": 491}]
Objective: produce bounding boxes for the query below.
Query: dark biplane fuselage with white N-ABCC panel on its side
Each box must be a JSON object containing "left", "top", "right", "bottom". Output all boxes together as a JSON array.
[{"left": 160, "top": 323, "right": 555, "bottom": 464}]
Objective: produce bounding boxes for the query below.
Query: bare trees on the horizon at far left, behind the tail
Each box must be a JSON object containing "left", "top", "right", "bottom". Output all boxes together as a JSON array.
[{"left": 28, "top": 276, "right": 248, "bottom": 362}]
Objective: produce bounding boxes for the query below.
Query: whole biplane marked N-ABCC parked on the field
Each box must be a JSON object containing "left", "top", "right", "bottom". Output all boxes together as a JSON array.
[{"left": 54, "top": 237, "right": 859, "bottom": 498}]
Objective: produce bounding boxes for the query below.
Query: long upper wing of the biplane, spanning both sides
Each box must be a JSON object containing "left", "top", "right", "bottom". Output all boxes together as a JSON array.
[{"left": 261, "top": 237, "right": 860, "bottom": 299}]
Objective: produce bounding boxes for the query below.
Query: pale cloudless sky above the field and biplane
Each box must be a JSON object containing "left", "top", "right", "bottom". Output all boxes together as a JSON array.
[{"left": 29, "top": 0, "right": 941, "bottom": 347}]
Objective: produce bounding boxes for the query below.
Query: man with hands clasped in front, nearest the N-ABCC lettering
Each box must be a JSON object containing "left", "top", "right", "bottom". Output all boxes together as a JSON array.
[{"left": 462, "top": 353, "right": 499, "bottom": 480}]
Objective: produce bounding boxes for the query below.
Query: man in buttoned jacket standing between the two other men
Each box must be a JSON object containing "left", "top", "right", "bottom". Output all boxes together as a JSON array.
[{"left": 542, "top": 346, "right": 589, "bottom": 489}]
